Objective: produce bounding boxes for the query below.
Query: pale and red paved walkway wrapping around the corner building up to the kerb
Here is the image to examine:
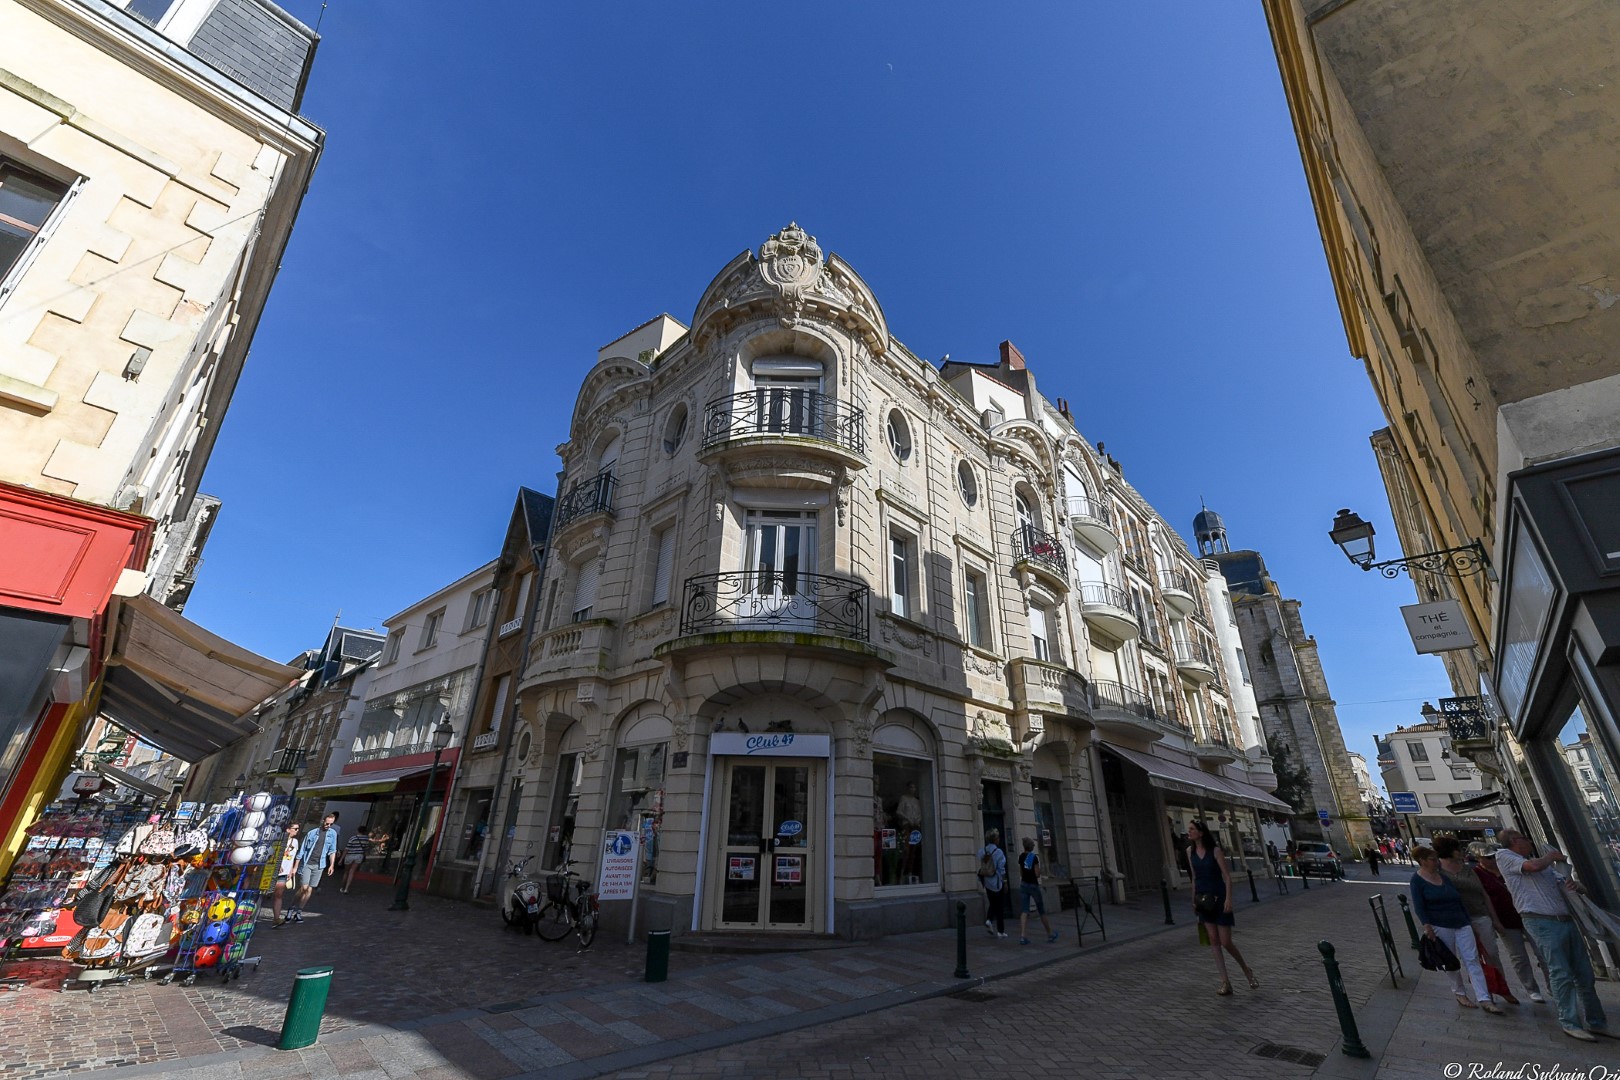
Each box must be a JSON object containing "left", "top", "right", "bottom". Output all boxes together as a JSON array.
[{"left": 0, "top": 882, "right": 1314, "bottom": 1080}]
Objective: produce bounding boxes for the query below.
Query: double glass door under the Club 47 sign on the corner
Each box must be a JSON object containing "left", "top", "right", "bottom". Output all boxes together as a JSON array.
[{"left": 710, "top": 758, "right": 823, "bottom": 929}]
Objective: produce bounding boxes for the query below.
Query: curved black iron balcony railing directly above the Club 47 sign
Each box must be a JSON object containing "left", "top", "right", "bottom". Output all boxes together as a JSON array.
[{"left": 680, "top": 570, "right": 870, "bottom": 641}]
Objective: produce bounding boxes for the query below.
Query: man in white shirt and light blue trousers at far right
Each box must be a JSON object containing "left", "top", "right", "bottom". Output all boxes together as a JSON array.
[{"left": 1497, "top": 829, "right": 1620, "bottom": 1043}]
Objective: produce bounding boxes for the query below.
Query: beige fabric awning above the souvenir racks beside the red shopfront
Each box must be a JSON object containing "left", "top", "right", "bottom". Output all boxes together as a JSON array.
[{"left": 100, "top": 596, "right": 300, "bottom": 761}]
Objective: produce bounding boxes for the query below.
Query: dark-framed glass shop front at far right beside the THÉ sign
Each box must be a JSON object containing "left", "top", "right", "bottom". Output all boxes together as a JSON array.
[{"left": 1481, "top": 450, "right": 1620, "bottom": 910}]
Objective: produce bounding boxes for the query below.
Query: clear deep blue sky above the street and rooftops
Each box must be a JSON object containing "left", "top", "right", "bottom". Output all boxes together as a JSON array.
[{"left": 186, "top": 0, "right": 1448, "bottom": 786}]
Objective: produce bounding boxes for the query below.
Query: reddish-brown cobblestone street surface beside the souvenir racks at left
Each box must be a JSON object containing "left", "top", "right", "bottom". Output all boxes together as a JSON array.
[{"left": 0, "top": 882, "right": 722, "bottom": 1080}]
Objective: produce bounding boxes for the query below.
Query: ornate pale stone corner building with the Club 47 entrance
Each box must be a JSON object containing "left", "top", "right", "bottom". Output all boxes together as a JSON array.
[{"left": 512, "top": 225, "right": 1275, "bottom": 938}]
